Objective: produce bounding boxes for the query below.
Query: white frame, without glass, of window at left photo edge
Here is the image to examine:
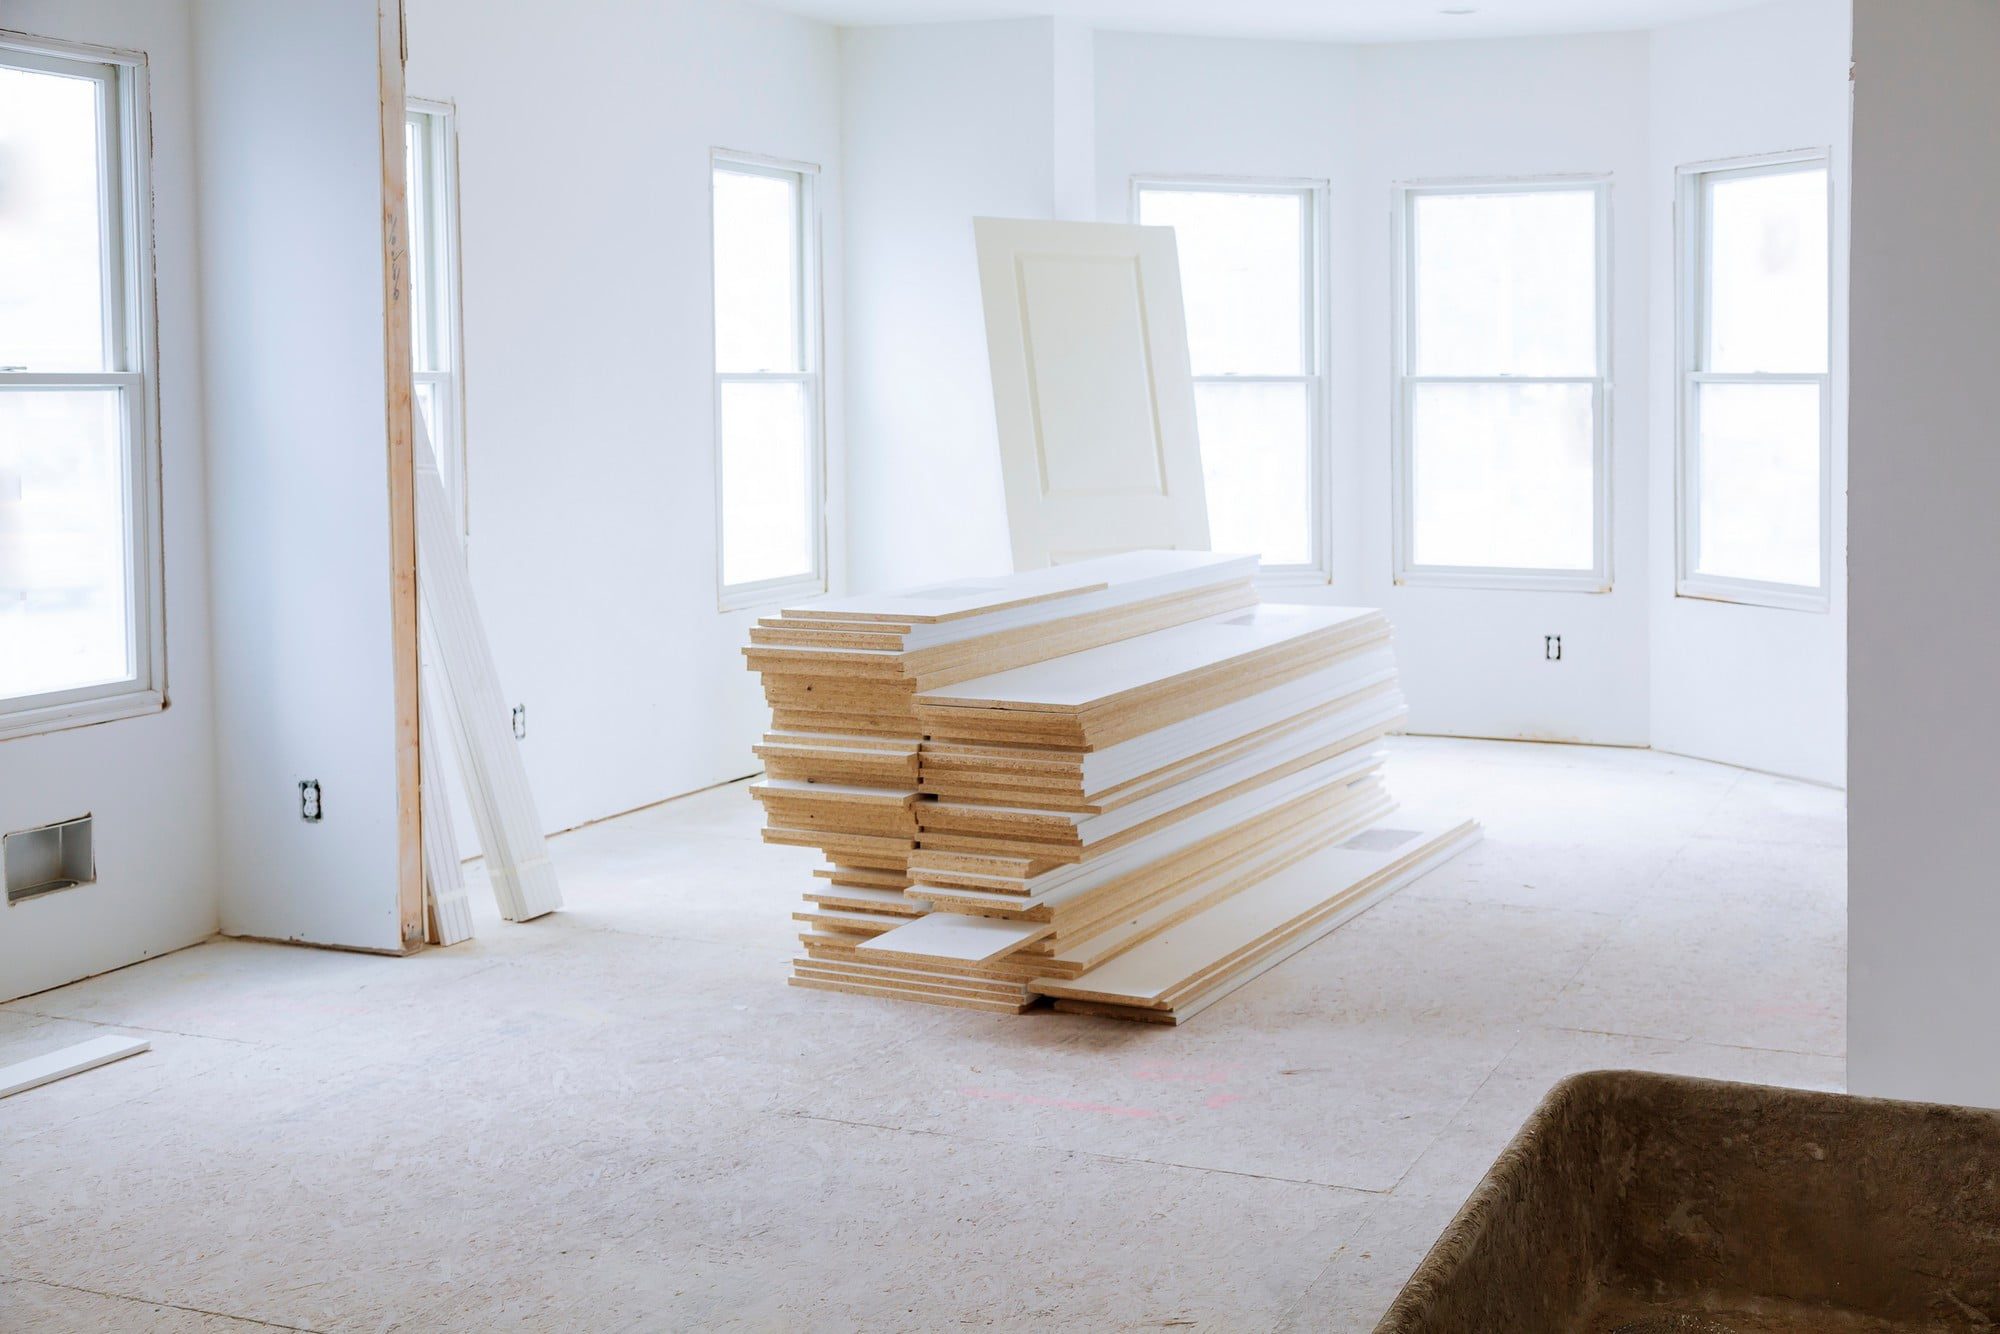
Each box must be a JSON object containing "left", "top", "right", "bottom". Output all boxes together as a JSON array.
[{"left": 0, "top": 32, "right": 168, "bottom": 740}]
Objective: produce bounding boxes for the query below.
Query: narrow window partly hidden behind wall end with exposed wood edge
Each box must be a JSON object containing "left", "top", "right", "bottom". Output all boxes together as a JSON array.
[{"left": 402, "top": 98, "right": 468, "bottom": 534}]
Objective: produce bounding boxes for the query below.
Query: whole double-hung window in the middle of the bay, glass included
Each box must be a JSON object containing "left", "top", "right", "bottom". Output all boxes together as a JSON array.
[{"left": 1394, "top": 180, "right": 1610, "bottom": 592}]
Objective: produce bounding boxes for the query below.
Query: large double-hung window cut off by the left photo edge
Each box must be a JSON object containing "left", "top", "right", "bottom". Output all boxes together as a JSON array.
[{"left": 0, "top": 42, "right": 166, "bottom": 736}]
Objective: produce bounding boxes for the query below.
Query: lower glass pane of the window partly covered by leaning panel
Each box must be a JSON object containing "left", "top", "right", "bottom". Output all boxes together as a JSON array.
[{"left": 1194, "top": 382, "right": 1312, "bottom": 566}]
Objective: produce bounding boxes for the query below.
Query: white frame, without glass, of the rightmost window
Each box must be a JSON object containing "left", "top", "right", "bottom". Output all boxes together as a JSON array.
[{"left": 1674, "top": 148, "right": 1834, "bottom": 612}]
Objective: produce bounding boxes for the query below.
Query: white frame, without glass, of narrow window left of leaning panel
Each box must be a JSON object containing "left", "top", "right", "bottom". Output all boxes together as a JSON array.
[{"left": 708, "top": 148, "right": 826, "bottom": 612}]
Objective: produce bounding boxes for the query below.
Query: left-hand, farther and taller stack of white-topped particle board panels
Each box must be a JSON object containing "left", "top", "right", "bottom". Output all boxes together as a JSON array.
[{"left": 744, "top": 552, "right": 1256, "bottom": 958}]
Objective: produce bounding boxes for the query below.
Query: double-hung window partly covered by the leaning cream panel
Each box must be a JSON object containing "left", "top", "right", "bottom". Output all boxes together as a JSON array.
[{"left": 1132, "top": 180, "right": 1328, "bottom": 582}]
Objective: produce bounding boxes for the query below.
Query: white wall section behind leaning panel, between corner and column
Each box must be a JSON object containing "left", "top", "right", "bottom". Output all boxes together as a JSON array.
[{"left": 840, "top": 18, "right": 1078, "bottom": 588}]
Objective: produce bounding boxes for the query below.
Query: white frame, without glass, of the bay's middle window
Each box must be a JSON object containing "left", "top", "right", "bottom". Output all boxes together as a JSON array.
[{"left": 1390, "top": 172, "right": 1612, "bottom": 592}]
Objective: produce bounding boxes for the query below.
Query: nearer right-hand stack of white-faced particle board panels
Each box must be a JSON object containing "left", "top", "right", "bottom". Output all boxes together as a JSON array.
[{"left": 744, "top": 554, "right": 1472, "bottom": 1022}]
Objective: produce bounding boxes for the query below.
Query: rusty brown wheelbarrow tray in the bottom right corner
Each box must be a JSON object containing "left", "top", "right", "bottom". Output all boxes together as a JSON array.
[{"left": 1376, "top": 1070, "right": 2000, "bottom": 1334}]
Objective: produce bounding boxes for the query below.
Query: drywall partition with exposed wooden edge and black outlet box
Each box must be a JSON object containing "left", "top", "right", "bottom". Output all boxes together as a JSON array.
[{"left": 194, "top": 0, "right": 402, "bottom": 950}]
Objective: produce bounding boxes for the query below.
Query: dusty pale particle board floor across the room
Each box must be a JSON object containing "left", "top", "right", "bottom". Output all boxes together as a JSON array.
[{"left": 0, "top": 738, "right": 1846, "bottom": 1334}]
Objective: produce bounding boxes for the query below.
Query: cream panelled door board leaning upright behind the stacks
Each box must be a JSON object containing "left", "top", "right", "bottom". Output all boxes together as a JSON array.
[{"left": 972, "top": 218, "right": 1208, "bottom": 570}]
